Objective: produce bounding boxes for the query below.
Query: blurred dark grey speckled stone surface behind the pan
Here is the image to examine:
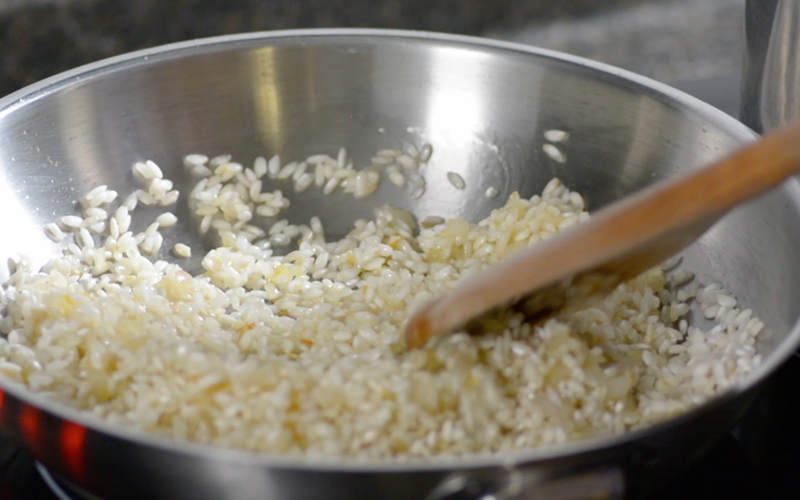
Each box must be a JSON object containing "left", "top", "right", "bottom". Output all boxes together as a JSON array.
[{"left": 0, "top": 0, "right": 744, "bottom": 101}]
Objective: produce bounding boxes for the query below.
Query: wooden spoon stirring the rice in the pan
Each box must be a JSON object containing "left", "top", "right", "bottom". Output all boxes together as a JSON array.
[{"left": 405, "top": 122, "right": 800, "bottom": 349}]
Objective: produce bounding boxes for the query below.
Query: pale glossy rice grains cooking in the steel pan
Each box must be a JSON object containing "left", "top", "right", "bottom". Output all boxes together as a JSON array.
[{"left": 0, "top": 145, "right": 762, "bottom": 459}]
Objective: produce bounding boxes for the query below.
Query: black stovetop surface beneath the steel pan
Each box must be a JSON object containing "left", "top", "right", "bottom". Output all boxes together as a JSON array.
[{"left": 0, "top": 354, "right": 800, "bottom": 500}]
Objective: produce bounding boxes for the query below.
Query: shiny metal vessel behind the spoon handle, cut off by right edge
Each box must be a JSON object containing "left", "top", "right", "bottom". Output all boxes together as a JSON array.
[{"left": 742, "top": 0, "right": 800, "bottom": 132}]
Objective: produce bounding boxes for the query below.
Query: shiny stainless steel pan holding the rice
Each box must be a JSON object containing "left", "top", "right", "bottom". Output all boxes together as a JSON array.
[{"left": 0, "top": 30, "right": 800, "bottom": 500}]
